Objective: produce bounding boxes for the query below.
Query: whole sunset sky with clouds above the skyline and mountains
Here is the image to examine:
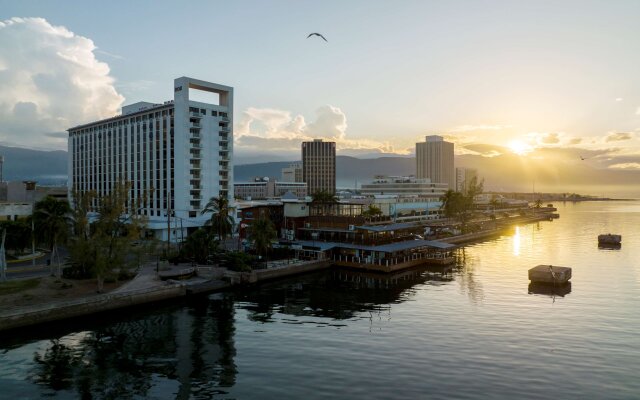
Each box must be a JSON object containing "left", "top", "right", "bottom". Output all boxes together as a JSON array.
[{"left": 0, "top": 0, "right": 640, "bottom": 192}]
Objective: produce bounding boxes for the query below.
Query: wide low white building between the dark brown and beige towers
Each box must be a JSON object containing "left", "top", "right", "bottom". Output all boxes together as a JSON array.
[{"left": 360, "top": 176, "right": 448, "bottom": 200}]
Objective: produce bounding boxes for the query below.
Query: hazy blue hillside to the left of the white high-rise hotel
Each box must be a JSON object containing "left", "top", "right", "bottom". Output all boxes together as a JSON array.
[{"left": 0, "top": 146, "right": 67, "bottom": 185}]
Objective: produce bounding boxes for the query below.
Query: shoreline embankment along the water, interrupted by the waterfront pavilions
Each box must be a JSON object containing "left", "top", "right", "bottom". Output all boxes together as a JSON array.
[{"left": 0, "top": 212, "right": 553, "bottom": 335}]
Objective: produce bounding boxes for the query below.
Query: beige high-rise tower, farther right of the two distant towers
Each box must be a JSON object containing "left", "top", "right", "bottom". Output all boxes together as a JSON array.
[{"left": 416, "top": 136, "right": 456, "bottom": 189}]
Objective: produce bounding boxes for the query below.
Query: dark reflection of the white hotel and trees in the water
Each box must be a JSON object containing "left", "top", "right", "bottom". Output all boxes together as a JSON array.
[{"left": 30, "top": 296, "right": 237, "bottom": 399}]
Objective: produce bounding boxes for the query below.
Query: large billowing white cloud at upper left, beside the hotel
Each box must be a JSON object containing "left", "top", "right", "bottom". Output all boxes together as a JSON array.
[{"left": 0, "top": 18, "right": 124, "bottom": 148}]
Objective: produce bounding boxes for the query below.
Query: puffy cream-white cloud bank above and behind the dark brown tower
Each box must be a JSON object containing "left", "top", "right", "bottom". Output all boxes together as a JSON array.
[{"left": 235, "top": 105, "right": 394, "bottom": 153}]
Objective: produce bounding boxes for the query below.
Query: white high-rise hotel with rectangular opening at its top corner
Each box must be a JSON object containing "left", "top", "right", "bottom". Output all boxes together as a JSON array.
[{"left": 68, "top": 77, "right": 233, "bottom": 241}]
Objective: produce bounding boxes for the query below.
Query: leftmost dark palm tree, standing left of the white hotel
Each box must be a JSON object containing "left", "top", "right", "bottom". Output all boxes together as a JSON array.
[{"left": 34, "top": 196, "right": 71, "bottom": 278}]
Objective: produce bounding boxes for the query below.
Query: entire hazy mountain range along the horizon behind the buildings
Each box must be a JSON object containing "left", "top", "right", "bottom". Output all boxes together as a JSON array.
[{"left": 5, "top": 146, "right": 640, "bottom": 197}]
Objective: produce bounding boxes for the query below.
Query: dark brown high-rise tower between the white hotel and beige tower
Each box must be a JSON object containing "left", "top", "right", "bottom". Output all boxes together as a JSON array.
[{"left": 302, "top": 139, "right": 336, "bottom": 195}]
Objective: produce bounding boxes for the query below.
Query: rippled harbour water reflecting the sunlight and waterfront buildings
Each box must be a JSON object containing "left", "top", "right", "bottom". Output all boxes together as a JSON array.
[{"left": 0, "top": 202, "right": 640, "bottom": 399}]
